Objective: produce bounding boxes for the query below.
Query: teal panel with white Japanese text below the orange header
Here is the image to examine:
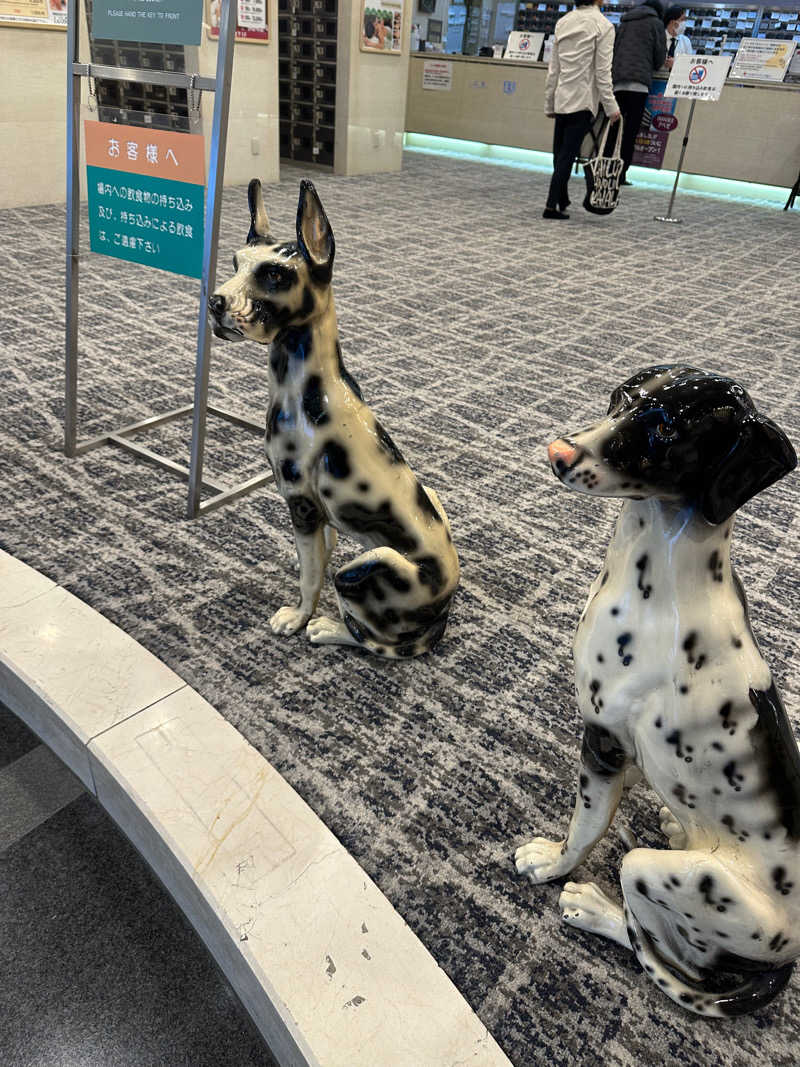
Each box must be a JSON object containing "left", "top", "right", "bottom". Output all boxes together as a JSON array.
[{"left": 86, "top": 166, "right": 205, "bottom": 277}]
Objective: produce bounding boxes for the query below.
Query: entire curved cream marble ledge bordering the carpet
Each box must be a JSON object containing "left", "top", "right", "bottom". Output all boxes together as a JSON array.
[{"left": 0, "top": 552, "right": 509, "bottom": 1067}]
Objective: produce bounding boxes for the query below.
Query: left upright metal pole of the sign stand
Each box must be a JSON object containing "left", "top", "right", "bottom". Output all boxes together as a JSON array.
[{"left": 64, "top": 0, "right": 81, "bottom": 456}]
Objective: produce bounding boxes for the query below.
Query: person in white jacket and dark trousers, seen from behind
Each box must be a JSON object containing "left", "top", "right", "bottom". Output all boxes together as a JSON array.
[{"left": 542, "top": 0, "right": 620, "bottom": 219}]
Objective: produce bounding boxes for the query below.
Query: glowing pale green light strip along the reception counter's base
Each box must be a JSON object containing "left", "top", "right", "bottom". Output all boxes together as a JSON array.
[{"left": 403, "top": 133, "right": 789, "bottom": 207}]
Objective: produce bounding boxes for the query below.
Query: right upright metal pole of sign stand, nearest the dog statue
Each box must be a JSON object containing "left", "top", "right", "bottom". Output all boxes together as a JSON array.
[{"left": 187, "top": 0, "right": 238, "bottom": 519}]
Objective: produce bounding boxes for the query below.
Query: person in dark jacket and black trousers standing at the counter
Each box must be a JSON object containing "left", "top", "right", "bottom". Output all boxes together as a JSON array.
[{"left": 606, "top": 0, "right": 667, "bottom": 186}]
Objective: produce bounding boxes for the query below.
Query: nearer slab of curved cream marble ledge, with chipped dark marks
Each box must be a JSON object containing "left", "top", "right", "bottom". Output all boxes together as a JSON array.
[{"left": 90, "top": 688, "right": 508, "bottom": 1067}]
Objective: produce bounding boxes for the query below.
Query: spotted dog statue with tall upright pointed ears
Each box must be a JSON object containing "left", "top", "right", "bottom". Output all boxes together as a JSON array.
[{"left": 208, "top": 179, "right": 459, "bottom": 656}]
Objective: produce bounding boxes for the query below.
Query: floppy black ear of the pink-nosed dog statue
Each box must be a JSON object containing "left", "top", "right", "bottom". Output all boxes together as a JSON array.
[{"left": 700, "top": 415, "right": 797, "bottom": 525}]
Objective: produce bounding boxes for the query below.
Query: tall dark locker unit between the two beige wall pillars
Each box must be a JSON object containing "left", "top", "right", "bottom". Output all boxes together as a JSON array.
[{"left": 277, "top": 0, "right": 338, "bottom": 166}]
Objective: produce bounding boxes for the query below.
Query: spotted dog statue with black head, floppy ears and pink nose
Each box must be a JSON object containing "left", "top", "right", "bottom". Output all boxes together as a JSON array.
[{"left": 516, "top": 366, "right": 800, "bottom": 1016}]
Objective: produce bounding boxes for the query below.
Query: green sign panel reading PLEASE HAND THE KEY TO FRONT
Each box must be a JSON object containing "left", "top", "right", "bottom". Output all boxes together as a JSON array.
[{"left": 92, "top": 0, "right": 203, "bottom": 45}]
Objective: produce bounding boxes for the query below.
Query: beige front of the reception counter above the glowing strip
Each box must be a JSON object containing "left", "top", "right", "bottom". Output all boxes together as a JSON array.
[{"left": 405, "top": 52, "right": 800, "bottom": 188}]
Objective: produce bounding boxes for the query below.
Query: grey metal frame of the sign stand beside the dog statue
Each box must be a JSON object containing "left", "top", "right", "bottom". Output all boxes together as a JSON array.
[{"left": 64, "top": 0, "right": 272, "bottom": 517}]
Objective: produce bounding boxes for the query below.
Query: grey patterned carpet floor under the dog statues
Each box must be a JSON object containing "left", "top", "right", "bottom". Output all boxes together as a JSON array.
[{"left": 0, "top": 154, "right": 800, "bottom": 1067}]
